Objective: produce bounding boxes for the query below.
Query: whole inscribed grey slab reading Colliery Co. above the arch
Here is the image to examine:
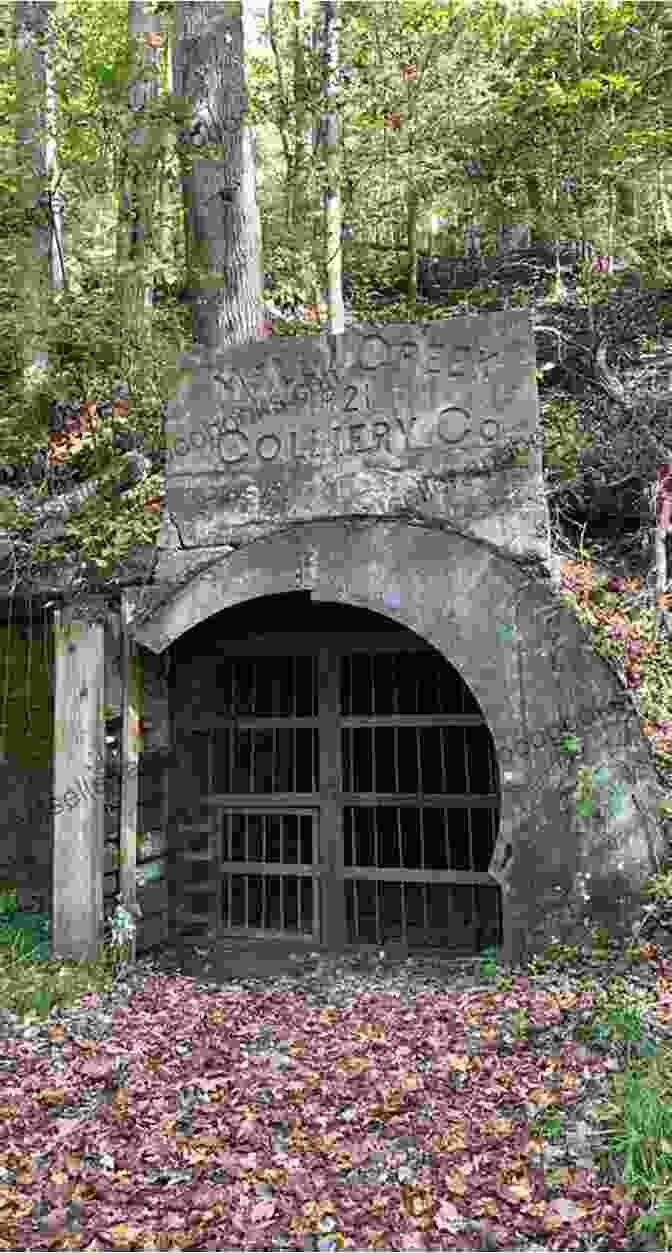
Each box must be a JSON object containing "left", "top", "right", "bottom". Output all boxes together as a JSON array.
[{"left": 145, "top": 309, "right": 550, "bottom": 595}]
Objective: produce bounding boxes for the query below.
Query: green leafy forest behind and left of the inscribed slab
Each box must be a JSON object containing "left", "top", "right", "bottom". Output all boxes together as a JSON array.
[{"left": 0, "top": 0, "right": 672, "bottom": 586}]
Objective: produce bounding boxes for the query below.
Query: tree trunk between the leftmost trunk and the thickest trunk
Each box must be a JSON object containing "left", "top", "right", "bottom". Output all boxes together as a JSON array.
[{"left": 117, "top": 0, "right": 160, "bottom": 360}]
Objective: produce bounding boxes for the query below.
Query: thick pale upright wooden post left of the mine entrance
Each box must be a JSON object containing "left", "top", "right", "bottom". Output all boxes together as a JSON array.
[{"left": 51, "top": 598, "right": 105, "bottom": 961}]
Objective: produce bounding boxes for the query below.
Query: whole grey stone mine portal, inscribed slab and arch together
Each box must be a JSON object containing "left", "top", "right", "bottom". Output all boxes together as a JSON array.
[{"left": 0, "top": 309, "right": 666, "bottom": 960}]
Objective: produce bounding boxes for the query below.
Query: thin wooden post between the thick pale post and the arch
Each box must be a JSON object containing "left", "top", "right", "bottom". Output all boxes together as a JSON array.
[{"left": 119, "top": 591, "right": 143, "bottom": 961}]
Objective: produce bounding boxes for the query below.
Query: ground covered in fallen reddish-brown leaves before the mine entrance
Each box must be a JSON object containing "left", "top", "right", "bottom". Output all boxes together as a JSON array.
[{"left": 0, "top": 954, "right": 672, "bottom": 1250}]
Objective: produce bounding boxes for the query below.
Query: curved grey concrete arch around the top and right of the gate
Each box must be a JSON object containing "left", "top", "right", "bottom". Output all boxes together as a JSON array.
[{"left": 133, "top": 520, "right": 663, "bottom": 961}]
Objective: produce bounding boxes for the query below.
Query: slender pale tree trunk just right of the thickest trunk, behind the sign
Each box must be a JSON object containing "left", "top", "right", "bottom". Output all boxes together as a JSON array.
[{"left": 320, "top": 0, "right": 345, "bottom": 335}]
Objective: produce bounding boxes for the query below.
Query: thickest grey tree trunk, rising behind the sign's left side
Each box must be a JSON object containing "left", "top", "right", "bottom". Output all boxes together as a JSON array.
[{"left": 173, "top": 0, "right": 262, "bottom": 350}]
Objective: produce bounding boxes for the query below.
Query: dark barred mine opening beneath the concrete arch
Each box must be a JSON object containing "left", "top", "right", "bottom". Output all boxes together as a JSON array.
[{"left": 174, "top": 596, "right": 500, "bottom": 952}]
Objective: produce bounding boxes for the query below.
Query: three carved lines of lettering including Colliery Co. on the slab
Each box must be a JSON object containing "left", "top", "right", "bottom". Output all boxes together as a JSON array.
[{"left": 168, "top": 320, "right": 534, "bottom": 477}]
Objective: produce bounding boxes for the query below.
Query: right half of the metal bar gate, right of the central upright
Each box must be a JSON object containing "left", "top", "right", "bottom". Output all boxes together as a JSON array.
[{"left": 341, "top": 654, "right": 499, "bottom": 944}]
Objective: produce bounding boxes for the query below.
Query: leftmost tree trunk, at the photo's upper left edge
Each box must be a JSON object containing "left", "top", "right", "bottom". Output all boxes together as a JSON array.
[{"left": 14, "top": 0, "right": 65, "bottom": 391}]
